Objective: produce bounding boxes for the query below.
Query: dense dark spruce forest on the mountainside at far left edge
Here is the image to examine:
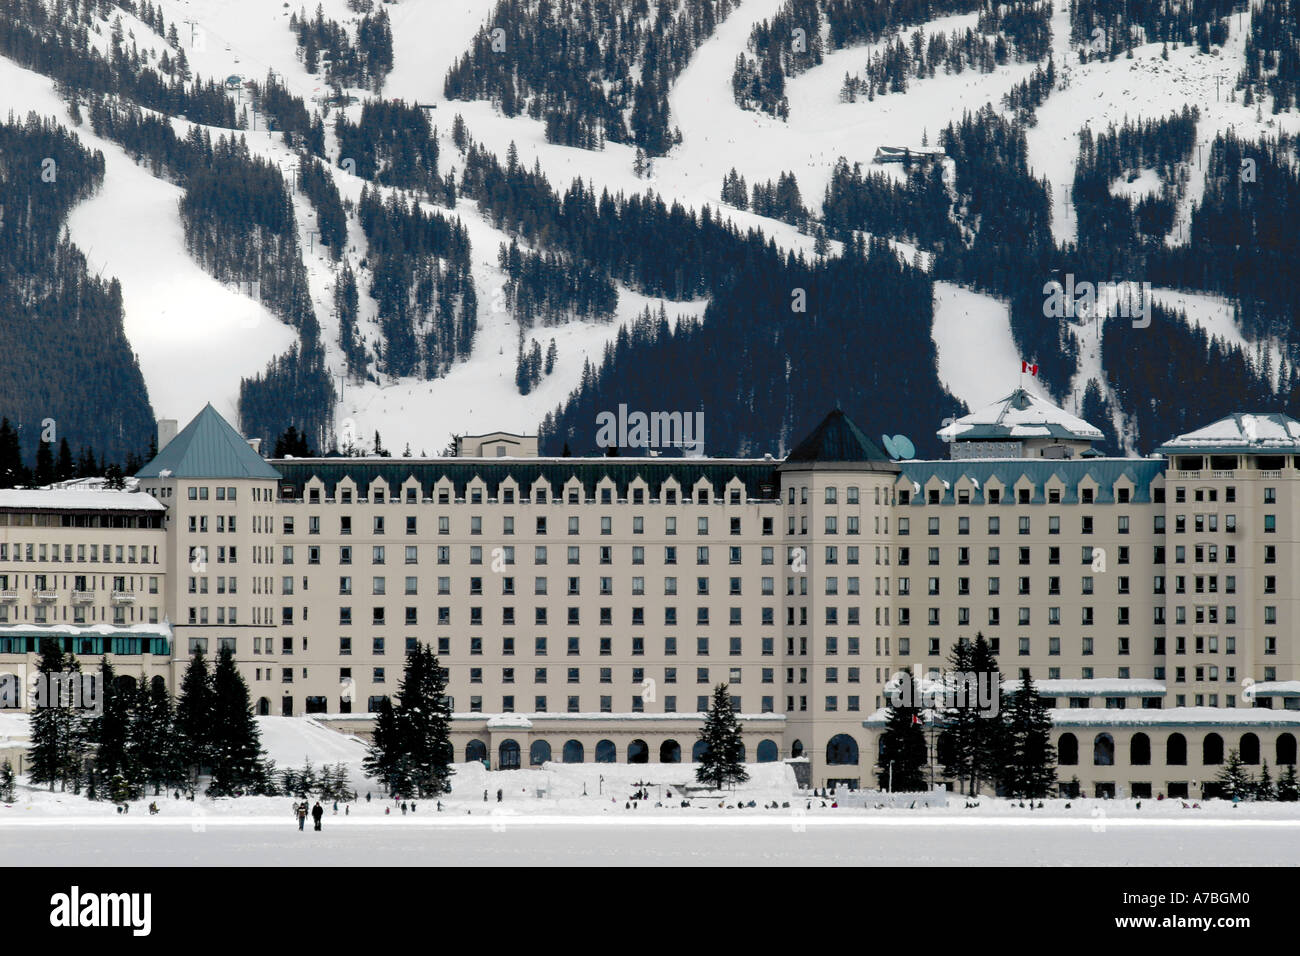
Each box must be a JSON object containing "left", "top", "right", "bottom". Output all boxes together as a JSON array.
[{"left": 0, "top": 114, "right": 153, "bottom": 470}]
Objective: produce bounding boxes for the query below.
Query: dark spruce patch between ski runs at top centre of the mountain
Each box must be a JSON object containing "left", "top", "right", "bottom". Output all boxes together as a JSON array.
[{"left": 443, "top": 0, "right": 735, "bottom": 156}]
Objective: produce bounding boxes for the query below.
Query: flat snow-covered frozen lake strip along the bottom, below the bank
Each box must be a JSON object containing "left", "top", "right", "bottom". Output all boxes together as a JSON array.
[{"left": 0, "top": 814, "right": 1300, "bottom": 866}]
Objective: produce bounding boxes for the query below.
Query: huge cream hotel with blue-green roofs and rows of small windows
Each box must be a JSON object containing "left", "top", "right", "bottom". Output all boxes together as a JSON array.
[{"left": 0, "top": 389, "right": 1300, "bottom": 797}]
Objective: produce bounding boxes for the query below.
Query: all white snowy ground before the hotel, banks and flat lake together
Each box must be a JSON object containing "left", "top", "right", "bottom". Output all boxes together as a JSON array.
[{"left": 0, "top": 715, "right": 1300, "bottom": 866}]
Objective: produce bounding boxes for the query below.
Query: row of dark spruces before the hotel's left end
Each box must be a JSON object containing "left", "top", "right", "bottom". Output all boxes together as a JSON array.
[{"left": 29, "top": 639, "right": 274, "bottom": 801}]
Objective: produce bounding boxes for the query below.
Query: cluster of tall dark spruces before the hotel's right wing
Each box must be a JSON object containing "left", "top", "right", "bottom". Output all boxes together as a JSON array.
[{"left": 876, "top": 633, "right": 1057, "bottom": 797}]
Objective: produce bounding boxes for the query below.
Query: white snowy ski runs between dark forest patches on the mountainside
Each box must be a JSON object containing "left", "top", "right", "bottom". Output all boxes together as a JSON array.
[{"left": 0, "top": 0, "right": 1300, "bottom": 454}]
